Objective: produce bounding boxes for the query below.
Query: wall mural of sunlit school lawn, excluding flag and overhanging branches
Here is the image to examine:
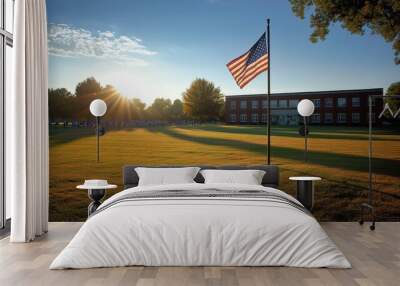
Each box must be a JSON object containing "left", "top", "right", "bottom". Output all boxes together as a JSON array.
[{"left": 47, "top": 0, "right": 400, "bottom": 221}]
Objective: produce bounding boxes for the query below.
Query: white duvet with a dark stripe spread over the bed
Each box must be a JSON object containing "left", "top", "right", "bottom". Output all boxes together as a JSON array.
[{"left": 50, "top": 184, "right": 351, "bottom": 269}]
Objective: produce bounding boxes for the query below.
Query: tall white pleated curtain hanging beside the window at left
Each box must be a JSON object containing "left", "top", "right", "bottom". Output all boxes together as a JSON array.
[{"left": 6, "top": 0, "right": 49, "bottom": 242}]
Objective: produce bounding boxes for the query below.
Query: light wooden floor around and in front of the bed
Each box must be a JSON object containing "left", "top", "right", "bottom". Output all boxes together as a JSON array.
[{"left": 0, "top": 222, "right": 400, "bottom": 286}]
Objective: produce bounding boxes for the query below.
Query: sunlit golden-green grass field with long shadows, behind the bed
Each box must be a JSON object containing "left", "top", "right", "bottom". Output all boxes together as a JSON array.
[{"left": 50, "top": 125, "right": 400, "bottom": 221}]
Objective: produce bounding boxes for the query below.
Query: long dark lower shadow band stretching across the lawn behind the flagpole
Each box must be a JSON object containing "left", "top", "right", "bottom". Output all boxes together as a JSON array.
[{"left": 148, "top": 127, "right": 400, "bottom": 177}]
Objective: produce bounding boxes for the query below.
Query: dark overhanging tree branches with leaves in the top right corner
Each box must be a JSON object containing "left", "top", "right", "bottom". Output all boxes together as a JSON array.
[{"left": 289, "top": 0, "right": 400, "bottom": 64}]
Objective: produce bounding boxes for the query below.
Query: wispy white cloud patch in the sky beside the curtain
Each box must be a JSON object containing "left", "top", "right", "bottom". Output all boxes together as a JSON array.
[{"left": 48, "top": 24, "right": 156, "bottom": 65}]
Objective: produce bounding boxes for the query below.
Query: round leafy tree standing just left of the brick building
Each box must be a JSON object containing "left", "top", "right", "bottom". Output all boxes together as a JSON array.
[{"left": 183, "top": 79, "right": 224, "bottom": 121}]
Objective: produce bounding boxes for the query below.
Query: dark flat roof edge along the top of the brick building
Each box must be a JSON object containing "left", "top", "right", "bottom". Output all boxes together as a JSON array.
[{"left": 225, "top": 88, "right": 383, "bottom": 98}]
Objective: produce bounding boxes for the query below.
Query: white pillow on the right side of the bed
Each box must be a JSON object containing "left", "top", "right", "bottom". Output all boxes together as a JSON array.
[{"left": 200, "top": 169, "right": 265, "bottom": 185}]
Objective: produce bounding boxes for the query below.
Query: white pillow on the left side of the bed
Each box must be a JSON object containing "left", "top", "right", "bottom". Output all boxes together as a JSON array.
[{"left": 135, "top": 167, "right": 200, "bottom": 186}]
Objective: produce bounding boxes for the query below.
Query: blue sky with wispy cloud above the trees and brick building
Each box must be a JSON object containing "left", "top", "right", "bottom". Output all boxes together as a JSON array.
[{"left": 47, "top": 0, "right": 400, "bottom": 103}]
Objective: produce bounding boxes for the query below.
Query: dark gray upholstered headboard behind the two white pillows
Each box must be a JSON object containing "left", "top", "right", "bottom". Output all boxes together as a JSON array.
[{"left": 122, "top": 165, "right": 279, "bottom": 189}]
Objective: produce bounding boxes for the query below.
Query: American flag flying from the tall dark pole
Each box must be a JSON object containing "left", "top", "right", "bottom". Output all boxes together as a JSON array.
[{"left": 226, "top": 33, "right": 268, "bottom": 88}]
